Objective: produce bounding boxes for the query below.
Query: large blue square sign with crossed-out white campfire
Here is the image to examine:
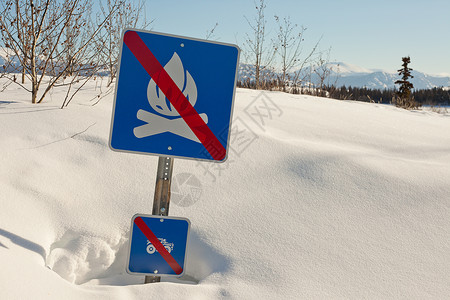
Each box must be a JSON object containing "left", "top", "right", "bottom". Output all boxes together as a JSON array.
[{"left": 110, "top": 29, "right": 239, "bottom": 161}]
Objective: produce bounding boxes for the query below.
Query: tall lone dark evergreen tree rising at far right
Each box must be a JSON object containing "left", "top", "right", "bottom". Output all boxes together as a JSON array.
[{"left": 395, "top": 56, "right": 418, "bottom": 109}]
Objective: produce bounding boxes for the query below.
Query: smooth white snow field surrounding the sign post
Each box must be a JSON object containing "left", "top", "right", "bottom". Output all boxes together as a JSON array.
[{"left": 0, "top": 78, "right": 450, "bottom": 300}]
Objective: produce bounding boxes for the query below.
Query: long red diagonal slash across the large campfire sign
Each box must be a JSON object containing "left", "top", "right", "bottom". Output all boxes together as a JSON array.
[{"left": 123, "top": 31, "right": 226, "bottom": 160}]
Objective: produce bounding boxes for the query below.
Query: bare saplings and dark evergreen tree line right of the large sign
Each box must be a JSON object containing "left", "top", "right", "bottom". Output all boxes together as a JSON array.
[{"left": 241, "top": 36, "right": 450, "bottom": 109}]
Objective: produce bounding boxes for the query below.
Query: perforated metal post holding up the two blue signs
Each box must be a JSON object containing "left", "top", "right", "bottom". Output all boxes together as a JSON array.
[{"left": 145, "top": 156, "right": 173, "bottom": 283}]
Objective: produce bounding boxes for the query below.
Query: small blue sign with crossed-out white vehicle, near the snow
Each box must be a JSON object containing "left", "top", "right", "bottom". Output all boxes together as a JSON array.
[{"left": 127, "top": 215, "right": 190, "bottom": 276}]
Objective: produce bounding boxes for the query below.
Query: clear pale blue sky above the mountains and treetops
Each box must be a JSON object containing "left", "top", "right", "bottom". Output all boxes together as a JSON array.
[{"left": 146, "top": 0, "right": 450, "bottom": 74}]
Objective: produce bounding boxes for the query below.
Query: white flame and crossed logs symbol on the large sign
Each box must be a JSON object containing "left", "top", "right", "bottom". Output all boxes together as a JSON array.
[{"left": 133, "top": 52, "right": 208, "bottom": 143}]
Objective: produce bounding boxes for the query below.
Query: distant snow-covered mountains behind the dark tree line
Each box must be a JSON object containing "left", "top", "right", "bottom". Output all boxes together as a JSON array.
[{"left": 239, "top": 62, "right": 450, "bottom": 89}]
